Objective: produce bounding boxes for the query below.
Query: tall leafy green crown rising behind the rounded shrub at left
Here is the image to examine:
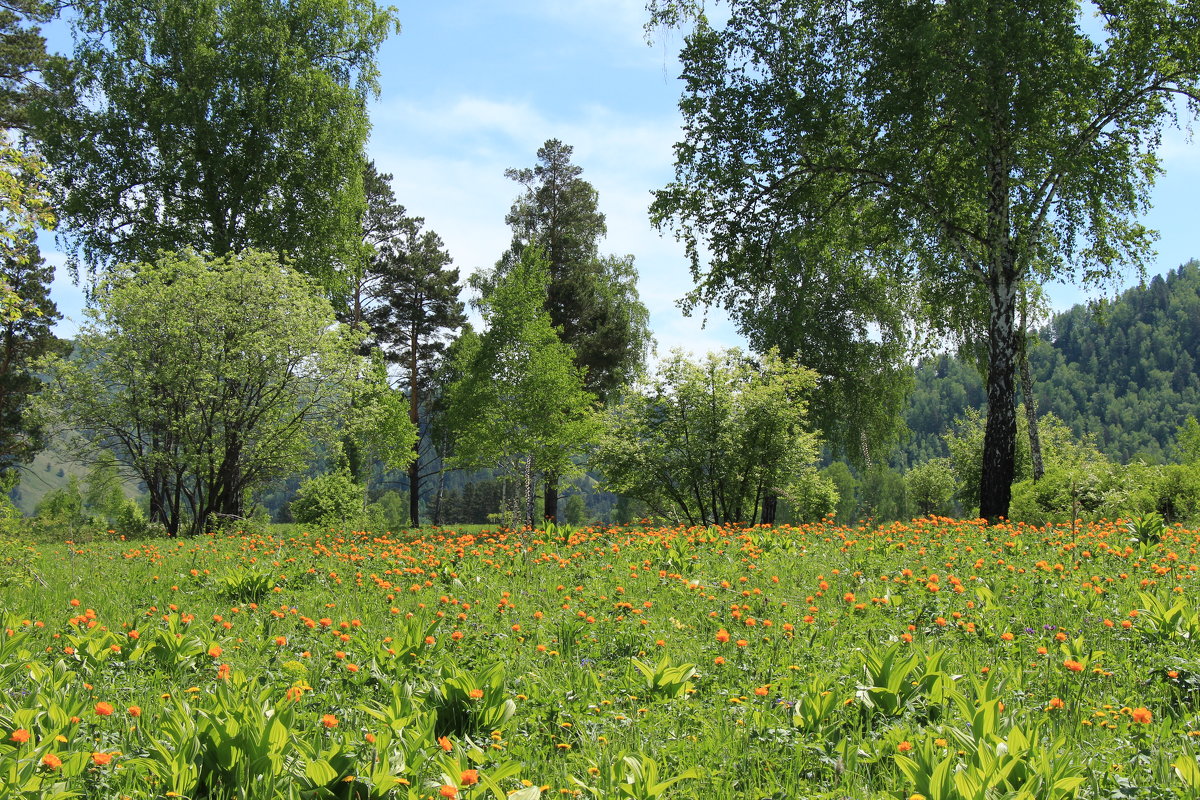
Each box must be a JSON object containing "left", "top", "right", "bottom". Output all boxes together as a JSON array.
[{"left": 32, "top": 0, "right": 395, "bottom": 290}]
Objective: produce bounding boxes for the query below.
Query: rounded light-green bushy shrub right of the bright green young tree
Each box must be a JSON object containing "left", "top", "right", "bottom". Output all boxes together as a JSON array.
[{"left": 592, "top": 350, "right": 832, "bottom": 524}]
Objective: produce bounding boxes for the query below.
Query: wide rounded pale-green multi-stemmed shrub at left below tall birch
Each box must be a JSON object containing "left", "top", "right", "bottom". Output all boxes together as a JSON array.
[{"left": 40, "top": 251, "right": 415, "bottom": 535}]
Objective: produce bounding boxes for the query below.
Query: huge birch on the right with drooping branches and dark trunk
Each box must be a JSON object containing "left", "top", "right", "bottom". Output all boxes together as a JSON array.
[{"left": 650, "top": 0, "right": 1200, "bottom": 518}]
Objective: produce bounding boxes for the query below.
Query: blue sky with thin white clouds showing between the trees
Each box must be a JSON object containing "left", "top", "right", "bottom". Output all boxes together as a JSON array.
[{"left": 35, "top": 0, "right": 1200, "bottom": 354}]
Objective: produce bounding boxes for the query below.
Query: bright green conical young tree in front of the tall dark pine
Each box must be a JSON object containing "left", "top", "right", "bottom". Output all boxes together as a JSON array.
[{"left": 446, "top": 247, "right": 594, "bottom": 525}]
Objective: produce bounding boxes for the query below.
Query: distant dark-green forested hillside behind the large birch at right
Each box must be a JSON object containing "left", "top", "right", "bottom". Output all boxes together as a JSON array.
[{"left": 895, "top": 259, "right": 1200, "bottom": 467}]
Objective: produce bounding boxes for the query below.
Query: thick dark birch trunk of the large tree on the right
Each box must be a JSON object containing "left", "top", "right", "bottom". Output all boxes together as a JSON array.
[{"left": 979, "top": 278, "right": 1019, "bottom": 522}]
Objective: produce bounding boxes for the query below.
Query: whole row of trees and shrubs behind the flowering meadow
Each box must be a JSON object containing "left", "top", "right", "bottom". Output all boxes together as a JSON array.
[{"left": 0, "top": 0, "right": 1200, "bottom": 533}]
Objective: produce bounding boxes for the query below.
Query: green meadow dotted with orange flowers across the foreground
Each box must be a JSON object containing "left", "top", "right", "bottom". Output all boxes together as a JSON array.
[{"left": 0, "top": 518, "right": 1200, "bottom": 800}]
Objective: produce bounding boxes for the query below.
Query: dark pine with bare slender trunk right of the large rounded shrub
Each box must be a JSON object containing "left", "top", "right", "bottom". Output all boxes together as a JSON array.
[{"left": 364, "top": 165, "right": 467, "bottom": 525}]
